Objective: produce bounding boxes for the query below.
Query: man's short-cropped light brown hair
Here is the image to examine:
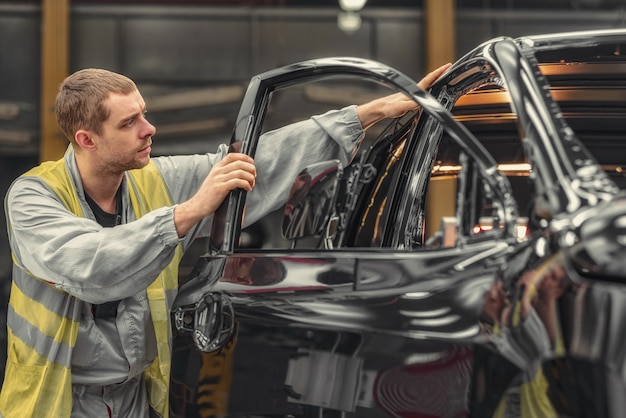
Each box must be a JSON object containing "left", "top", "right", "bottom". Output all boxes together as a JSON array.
[{"left": 54, "top": 68, "right": 137, "bottom": 143}]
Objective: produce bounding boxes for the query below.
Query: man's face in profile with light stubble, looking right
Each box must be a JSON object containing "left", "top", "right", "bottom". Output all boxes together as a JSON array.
[{"left": 94, "top": 91, "right": 156, "bottom": 173}]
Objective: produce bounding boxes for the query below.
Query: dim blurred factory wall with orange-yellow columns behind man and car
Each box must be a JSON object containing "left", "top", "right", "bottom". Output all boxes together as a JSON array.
[{"left": 0, "top": 0, "right": 626, "bottom": 379}]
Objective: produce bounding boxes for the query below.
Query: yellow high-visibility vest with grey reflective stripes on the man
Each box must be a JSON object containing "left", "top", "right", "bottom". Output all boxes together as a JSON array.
[{"left": 0, "top": 160, "right": 182, "bottom": 418}]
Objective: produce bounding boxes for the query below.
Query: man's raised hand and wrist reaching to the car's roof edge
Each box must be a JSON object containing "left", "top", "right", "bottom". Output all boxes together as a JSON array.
[{"left": 357, "top": 63, "right": 452, "bottom": 129}]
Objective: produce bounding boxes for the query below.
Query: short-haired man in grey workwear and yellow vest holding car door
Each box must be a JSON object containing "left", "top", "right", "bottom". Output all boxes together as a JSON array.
[{"left": 0, "top": 65, "right": 448, "bottom": 418}]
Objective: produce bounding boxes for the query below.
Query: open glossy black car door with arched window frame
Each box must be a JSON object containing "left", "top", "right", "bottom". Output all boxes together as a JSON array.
[{"left": 171, "top": 59, "right": 517, "bottom": 416}]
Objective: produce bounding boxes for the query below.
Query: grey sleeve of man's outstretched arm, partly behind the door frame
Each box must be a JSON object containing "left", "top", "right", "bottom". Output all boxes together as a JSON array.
[{"left": 154, "top": 106, "right": 364, "bottom": 229}]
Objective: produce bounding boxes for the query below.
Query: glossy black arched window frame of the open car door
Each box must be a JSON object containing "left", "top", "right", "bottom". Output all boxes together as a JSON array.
[{"left": 211, "top": 57, "right": 516, "bottom": 253}]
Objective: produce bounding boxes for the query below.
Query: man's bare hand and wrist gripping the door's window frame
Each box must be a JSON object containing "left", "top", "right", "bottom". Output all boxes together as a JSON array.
[{"left": 174, "top": 153, "right": 256, "bottom": 237}]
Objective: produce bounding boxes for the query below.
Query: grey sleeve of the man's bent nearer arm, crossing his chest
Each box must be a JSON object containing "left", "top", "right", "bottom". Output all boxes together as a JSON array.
[{"left": 5, "top": 177, "right": 179, "bottom": 303}]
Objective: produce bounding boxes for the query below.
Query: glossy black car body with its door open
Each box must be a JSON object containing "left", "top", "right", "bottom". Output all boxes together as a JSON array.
[{"left": 170, "top": 30, "right": 626, "bottom": 418}]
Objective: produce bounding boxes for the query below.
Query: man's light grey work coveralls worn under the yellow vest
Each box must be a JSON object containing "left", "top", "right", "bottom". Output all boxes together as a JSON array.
[{"left": 5, "top": 106, "right": 363, "bottom": 416}]
